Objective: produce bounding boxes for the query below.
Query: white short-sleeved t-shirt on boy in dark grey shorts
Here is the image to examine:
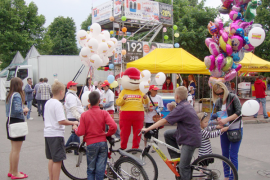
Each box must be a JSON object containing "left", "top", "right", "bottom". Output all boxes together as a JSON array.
[{"left": 44, "top": 99, "right": 66, "bottom": 137}]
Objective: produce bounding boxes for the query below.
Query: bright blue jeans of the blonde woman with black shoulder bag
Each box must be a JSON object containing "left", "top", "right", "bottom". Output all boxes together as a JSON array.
[{"left": 220, "top": 128, "right": 243, "bottom": 180}]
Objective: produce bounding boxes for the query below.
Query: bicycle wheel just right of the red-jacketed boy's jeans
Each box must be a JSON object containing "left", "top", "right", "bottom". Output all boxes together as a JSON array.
[{"left": 114, "top": 157, "right": 149, "bottom": 180}]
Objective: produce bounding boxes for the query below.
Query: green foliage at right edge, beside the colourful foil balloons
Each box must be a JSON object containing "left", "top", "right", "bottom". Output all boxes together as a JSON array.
[{"left": 255, "top": 0, "right": 270, "bottom": 61}]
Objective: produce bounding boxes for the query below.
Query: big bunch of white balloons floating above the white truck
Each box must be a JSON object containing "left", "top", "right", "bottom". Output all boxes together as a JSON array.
[{"left": 77, "top": 23, "right": 117, "bottom": 69}]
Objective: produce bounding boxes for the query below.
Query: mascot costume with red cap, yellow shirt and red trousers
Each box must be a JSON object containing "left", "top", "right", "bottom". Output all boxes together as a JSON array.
[{"left": 116, "top": 68, "right": 149, "bottom": 149}]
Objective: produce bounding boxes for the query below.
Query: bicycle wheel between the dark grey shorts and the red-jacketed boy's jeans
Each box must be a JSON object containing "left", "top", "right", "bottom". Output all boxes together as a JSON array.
[{"left": 61, "top": 147, "right": 87, "bottom": 180}]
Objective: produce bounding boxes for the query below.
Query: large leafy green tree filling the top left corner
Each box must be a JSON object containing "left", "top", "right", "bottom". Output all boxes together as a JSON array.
[{"left": 0, "top": 0, "right": 45, "bottom": 68}]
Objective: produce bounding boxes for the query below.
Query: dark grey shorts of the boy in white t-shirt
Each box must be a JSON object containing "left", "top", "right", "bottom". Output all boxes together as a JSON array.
[{"left": 45, "top": 137, "right": 66, "bottom": 162}]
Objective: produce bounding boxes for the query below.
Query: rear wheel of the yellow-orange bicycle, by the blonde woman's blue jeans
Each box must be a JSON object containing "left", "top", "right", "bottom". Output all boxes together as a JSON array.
[{"left": 192, "top": 154, "right": 238, "bottom": 180}]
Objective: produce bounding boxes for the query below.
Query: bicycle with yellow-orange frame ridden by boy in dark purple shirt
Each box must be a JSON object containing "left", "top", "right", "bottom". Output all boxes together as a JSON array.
[{"left": 127, "top": 130, "right": 238, "bottom": 180}]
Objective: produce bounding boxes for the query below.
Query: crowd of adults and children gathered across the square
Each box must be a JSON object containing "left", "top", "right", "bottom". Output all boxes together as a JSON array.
[{"left": 6, "top": 73, "right": 268, "bottom": 180}]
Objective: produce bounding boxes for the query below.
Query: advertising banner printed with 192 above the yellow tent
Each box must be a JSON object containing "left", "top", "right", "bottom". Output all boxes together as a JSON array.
[{"left": 125, "top": 41, "right": 173, "bottom": 62}]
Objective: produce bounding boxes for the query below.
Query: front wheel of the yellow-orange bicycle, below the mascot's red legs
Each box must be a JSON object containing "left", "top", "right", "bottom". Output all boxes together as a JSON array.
[{"left": 126, "top": 149, "right": 158, "bottom": 180}]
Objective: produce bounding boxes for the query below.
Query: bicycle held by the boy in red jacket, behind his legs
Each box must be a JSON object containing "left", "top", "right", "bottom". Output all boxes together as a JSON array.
[{"left": 61, "top": 132, "right": 148, "bottom": 180}]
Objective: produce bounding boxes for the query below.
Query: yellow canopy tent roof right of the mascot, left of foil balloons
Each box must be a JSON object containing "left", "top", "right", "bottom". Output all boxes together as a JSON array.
[{"left": 127, "top": 48, "right": 210, "bottom": 75}]
